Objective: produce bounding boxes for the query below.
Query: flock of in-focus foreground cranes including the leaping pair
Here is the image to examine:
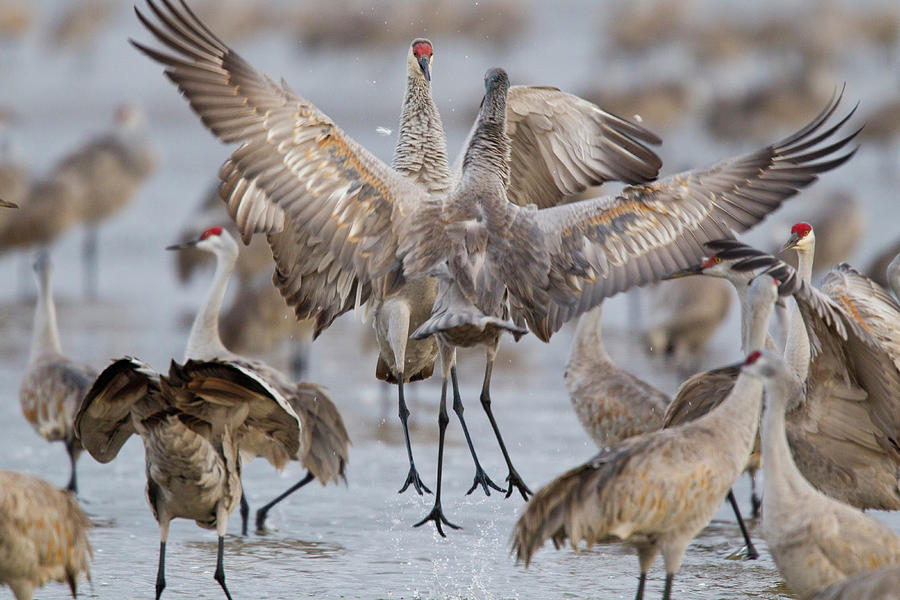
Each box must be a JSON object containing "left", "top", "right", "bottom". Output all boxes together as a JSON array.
[{"left": 0, "top": 0, "right": 900, "bottom": 600}]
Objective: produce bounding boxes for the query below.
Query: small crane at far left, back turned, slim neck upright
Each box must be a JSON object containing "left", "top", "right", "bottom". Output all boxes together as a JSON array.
[{"left": 19, "top": 251, "right": 97, "bottom": 493}]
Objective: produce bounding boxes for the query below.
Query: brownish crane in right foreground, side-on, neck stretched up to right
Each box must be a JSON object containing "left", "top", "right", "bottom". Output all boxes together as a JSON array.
[{"left": 512, "top": 276, "right": 778, "bottom": 600}]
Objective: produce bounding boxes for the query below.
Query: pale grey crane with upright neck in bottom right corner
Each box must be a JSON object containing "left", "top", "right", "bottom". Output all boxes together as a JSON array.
[{"left": 751, "top": 351, "right": 900, "bottom": 598}]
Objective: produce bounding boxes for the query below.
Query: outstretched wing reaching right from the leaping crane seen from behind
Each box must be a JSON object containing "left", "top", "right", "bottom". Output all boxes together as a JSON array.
[{"left": 513, "top": 95, "right": 858, "bottom": 340}]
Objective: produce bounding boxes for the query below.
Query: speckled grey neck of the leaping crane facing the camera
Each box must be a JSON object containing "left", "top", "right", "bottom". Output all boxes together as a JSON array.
[{"left": 391, "top": 73, "right": 450, "bottom": 194}]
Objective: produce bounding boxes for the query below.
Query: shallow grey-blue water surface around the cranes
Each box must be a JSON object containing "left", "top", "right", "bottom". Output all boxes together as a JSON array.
[{"left": 0, "top": 2, "right": 900, "bottom": 599}]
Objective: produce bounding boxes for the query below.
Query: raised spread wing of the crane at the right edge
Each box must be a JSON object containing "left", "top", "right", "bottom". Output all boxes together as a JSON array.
[{"left": 724, "top": 240, "right": 900, "bottom": 464}]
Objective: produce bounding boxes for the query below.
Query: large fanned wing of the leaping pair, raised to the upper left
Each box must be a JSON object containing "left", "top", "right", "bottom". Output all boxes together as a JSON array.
[{"left": 132, "top": 0, "right": 436, "bottom": 338}]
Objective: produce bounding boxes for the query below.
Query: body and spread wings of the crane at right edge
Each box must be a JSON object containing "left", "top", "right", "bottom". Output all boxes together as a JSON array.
[{"left": 714, "top": 240, "right": 900, "bottom": 510}]
